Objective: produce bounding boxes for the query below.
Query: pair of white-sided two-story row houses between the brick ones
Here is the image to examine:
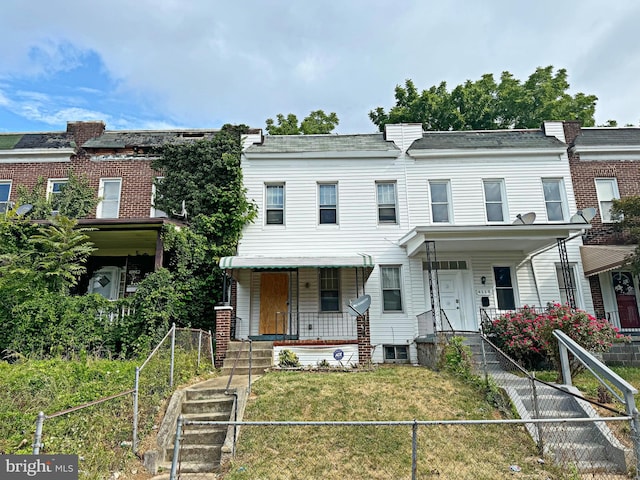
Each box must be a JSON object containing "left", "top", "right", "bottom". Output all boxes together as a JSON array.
[{"left": 220, "top": 125, "right": 592, "bottom": 363}]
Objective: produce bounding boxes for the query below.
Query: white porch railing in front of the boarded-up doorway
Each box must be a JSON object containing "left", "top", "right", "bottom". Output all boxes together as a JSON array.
[{"left": 275, "top": 312, "right": 358, "bottom": 340}]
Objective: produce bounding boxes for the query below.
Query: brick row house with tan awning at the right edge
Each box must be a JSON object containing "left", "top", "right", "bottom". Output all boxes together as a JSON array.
[{"left": 564, "top": 122, "right": 640, "bottom": 335}]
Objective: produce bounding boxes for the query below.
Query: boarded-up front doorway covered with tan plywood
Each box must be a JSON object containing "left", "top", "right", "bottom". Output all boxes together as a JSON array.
[{"left": 260, "top": 273, "right": 289, "bottom": 335}]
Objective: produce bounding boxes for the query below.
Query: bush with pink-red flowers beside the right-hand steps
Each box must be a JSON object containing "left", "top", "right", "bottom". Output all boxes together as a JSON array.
[{"left": 486, "top": 303, "right": 627, "bottom": 374}]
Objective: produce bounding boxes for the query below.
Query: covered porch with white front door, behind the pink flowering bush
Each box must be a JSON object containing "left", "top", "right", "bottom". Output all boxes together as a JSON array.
[{"left": 400, "top": 223, "right": 590, "bottom": 338}]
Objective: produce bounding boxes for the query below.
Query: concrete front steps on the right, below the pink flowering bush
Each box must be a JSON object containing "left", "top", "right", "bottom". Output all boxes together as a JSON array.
[{"left": 463, "top": 333, "right": 630, "bottom": 473}]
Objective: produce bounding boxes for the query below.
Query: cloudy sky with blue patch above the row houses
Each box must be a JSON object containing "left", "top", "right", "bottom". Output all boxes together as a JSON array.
[{"left": 0, "top": 0, "right": 640, "bottom": 133}]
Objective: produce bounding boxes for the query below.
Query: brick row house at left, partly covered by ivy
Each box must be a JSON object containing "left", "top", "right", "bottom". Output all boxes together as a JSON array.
[{"left": 0, "top": 122, "right": 224, "bottom": 299}]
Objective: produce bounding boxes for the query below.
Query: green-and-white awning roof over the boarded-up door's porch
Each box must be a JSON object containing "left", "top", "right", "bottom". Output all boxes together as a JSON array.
[{"left": 220, "top": 253, "right": 374, "bottom": 269}]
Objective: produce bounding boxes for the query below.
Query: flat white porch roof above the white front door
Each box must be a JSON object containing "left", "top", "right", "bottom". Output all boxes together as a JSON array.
[{"left": 399, "top": 223, "right": 591, "bottom": 257}]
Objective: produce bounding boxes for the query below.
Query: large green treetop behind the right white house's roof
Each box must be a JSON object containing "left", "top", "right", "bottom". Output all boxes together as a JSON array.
[{"left": 369, "top": 66, "right": 598, "bottom": 131}]
